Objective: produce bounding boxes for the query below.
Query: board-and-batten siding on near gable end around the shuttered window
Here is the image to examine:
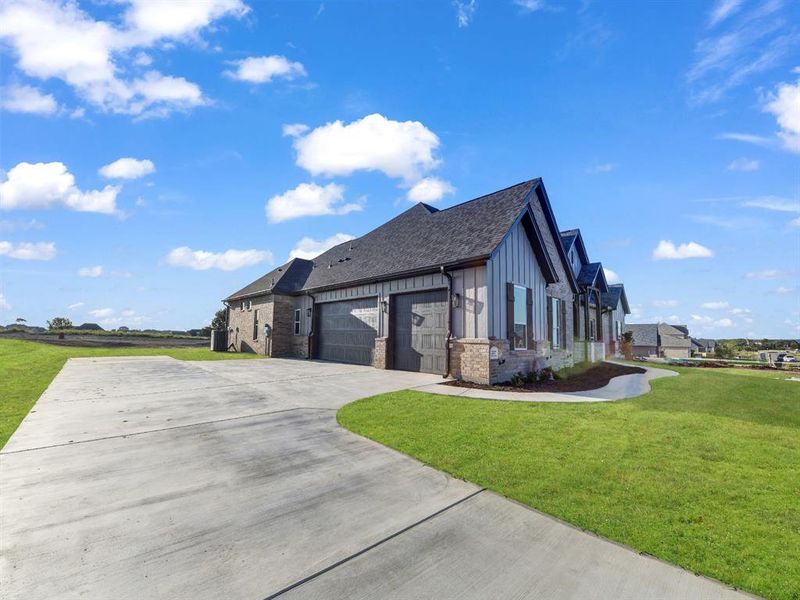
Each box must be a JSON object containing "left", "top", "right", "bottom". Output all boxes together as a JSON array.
[{"left": 486, "top": 223, "right": 547, "bottom": 341}]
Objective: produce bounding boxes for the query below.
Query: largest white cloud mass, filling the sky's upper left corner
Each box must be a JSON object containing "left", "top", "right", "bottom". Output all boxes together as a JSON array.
[{"left": 0, "top": 0, "right": 248, "bottom": 116}]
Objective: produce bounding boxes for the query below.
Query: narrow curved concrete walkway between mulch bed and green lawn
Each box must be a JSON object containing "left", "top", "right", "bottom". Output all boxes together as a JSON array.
[{"left": 414, "top": 361, "right": 678, "bottom": 402}]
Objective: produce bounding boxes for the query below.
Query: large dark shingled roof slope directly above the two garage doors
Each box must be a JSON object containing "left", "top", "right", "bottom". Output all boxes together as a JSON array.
[{"left": 304, "top": 179, "right": 540, "bottom": 290}]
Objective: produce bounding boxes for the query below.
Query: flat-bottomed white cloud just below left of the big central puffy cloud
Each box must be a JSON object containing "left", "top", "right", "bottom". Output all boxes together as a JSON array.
[{"left": 266, "top": 183, "right": 362, "bottom": 223}]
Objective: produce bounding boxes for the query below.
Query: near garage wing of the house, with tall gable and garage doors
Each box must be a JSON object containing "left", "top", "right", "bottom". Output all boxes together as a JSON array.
[{"left": 224, "top": 179, "right": 592, "bottom": 383}]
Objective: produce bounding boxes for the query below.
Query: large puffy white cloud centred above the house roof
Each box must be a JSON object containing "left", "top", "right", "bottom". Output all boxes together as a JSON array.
[{"left": 293, "top": 114, "right": 440, "bottom": 184}]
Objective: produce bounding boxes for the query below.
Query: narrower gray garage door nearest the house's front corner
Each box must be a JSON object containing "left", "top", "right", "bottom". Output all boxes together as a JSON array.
[{"left": 392, "top": 290, "right": 447, "bottom": 374}]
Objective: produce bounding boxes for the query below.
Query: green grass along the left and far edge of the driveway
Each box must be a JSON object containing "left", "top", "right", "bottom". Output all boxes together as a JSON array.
[{"left": 0, "top": 339, "right": 263, "bottom": 448}]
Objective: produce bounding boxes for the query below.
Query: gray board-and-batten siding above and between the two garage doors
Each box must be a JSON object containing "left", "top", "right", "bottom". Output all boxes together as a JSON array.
[{"left": 295, "top": 266, "right": 488, "bottom": 338}]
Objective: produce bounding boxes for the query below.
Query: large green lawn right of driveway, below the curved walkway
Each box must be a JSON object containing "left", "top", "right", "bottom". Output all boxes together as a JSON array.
[{"left": 338, "top": 368, "right": 800, "bottom": 600}]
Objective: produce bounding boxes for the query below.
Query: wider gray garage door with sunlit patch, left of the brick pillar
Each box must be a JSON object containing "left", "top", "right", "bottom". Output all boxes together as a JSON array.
[{"left": 317, "top": 298, "right": 378, "bottom": 365}]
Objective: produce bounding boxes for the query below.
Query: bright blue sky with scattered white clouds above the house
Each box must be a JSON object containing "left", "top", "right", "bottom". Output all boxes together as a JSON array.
[{"left": 0, "top": 0, "right": 800, "bottom": 337}]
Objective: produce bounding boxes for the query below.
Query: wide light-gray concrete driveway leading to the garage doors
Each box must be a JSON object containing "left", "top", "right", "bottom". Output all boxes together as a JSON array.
[{"left": 0, "top": 358, "right": 742, "bottom": 600}]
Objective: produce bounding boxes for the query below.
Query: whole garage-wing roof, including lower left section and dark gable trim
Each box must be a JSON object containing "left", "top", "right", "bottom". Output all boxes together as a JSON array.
[{"left": 226, "top": 178, "right": 577, "bottom": 300}]
